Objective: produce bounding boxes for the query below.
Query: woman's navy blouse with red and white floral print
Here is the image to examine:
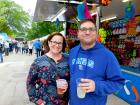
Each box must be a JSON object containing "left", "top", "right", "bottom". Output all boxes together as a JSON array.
[{"left": 26, "top": 55, "right": 69, "bottom": 105}]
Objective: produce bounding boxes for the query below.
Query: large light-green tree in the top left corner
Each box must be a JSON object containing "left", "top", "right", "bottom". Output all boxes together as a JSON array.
[{"left": 0, "top": 0, "right": 30, "bottom": 35}]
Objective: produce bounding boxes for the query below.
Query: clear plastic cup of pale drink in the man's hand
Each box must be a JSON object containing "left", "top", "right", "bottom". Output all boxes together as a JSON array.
[{"left": 76, "top": 78, "right": 86, "bottom": 98}]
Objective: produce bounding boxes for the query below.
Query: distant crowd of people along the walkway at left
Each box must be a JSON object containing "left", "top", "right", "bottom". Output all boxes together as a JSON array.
[{"left": 0, "top": 39, "right": 44, "bottom": 63}]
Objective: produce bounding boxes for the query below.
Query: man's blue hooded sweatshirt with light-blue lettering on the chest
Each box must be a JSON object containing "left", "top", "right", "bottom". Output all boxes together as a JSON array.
[{"left": 69, "top": 42, "right": 125, "bottom": 105}]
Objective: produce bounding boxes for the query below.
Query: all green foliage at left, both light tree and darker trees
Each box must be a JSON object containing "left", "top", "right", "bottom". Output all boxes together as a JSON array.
[{"left": 0, "top": 0, "right": 63, "bottom": 40}]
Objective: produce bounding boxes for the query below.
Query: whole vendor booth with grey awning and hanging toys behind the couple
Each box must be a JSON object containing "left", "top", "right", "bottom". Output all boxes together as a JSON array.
[{"left": 34, "top": 0, "right": 140, "bottom": 105}]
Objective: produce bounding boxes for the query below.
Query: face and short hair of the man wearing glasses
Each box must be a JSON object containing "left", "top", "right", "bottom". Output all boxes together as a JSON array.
[{"left": 78, "top": 21, "right": 97, "bottom": 45}]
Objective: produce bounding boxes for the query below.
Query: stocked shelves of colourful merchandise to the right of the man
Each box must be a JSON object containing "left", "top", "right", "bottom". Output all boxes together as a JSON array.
[{"left": 105, "top": 16, "right": 140, "bottom": 69}]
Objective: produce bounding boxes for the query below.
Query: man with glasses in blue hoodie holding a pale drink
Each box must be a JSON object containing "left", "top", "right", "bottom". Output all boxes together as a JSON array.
[{"left": 69, "top": 19, "right": 125, "bottom": 105}]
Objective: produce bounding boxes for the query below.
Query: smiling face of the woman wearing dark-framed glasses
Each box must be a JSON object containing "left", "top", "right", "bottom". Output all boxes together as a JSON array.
[{"left": 48, "top": 35, "right": 63, "bottom": 54}]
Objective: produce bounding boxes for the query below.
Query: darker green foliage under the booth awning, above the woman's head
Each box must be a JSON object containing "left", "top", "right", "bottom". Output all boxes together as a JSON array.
[{"left": 27, "top": 21, "right": 63, "bottom": 40}]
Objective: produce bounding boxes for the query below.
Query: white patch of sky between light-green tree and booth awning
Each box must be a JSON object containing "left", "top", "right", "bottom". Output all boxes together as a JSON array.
[{"left": 12, "top": 0, "right": 37, "bottom": 16}]
